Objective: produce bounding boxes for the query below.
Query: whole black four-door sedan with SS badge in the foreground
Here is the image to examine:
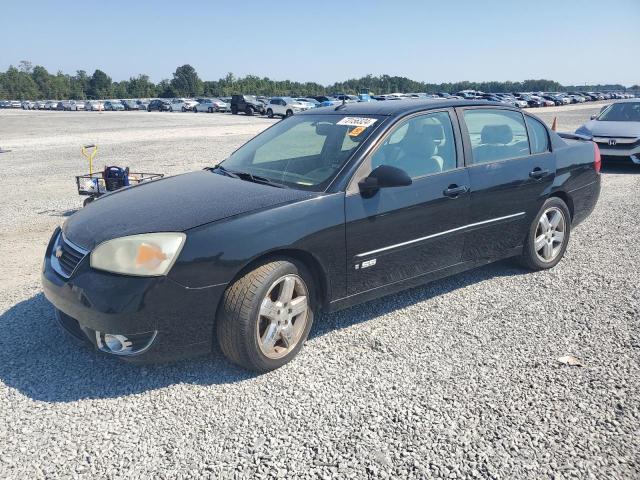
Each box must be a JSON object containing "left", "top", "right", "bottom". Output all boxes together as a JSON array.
[{"left": 42, "top": 100, "right": 600, "bottom": 371}]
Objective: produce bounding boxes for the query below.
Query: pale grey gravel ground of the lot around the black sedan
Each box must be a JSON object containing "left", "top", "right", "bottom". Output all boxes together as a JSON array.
[{"left": 0, "top": 105, "right": 640, "bottom": 479}]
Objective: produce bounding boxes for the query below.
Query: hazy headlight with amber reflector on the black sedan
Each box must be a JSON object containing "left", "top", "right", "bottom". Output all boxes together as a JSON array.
[{"left": 91, "top": 232, "right": 187, "bottom": 277}]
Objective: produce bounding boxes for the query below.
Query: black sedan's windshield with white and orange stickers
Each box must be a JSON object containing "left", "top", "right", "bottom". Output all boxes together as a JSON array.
[{"left": 221, "top": 114, "right": 383, "bottom": 191}]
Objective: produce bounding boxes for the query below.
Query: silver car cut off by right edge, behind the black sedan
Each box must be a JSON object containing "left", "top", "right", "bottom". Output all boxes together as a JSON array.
[{"left": 576, "top": 99, "right": 640, "bottom": 165}]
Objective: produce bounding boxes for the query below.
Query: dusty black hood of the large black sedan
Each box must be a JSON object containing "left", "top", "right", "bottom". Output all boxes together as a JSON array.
[{"left": 62, "top": 170, "right": 318, "bottom": 250}]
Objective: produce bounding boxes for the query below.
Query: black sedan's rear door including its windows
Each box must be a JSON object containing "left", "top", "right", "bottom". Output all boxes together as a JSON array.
[{"left": 458, "top": 107, "right": 556, "bottom": 260}]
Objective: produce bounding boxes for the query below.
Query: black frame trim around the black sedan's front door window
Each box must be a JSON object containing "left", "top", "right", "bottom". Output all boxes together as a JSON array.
[{"left": 345, "top": 108, "right": 465, "bottom": 196}]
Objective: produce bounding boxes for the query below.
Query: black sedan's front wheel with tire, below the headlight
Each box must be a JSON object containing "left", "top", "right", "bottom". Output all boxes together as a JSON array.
[{"left": 216, "top": 260, "right": 314, "bottom": 372}]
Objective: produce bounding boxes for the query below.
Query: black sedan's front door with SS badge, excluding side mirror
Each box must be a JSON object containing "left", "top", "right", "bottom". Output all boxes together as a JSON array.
[{"left": 345, "top": 110, "right": 469, "bottom": 295}]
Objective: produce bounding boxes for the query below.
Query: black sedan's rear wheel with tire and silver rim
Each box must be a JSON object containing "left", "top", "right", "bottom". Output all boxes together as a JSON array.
[{"left": 520, "top": 197, "right": 571, "bottom": 270}]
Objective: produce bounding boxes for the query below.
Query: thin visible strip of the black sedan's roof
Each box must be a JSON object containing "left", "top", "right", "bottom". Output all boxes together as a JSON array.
[{"left": 298, "top": 98, "right": 509, "bottom": 116}]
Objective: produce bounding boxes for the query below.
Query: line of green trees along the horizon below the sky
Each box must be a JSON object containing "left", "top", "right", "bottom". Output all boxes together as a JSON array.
[{"left": 0, "top": 60, "right": 640, "bottom": 100}]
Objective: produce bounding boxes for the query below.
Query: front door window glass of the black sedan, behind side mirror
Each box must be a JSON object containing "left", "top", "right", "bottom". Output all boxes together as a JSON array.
[{"left": 371, "top": 112, "right": 456, "bottom": 178}]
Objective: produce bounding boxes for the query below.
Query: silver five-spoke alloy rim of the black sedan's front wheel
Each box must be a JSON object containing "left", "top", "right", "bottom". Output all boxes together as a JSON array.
[{"left": 256, "top": 274, "right": 309, "bottom": 359}]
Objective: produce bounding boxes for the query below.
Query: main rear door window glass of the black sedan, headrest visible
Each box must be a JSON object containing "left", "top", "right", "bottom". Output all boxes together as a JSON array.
[{"left": 464, "top": 108, "right": 529, "bottom": 164}]
